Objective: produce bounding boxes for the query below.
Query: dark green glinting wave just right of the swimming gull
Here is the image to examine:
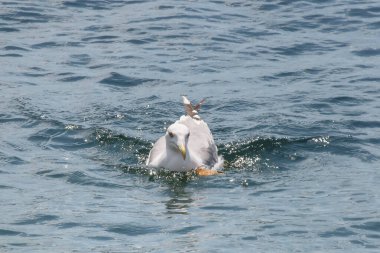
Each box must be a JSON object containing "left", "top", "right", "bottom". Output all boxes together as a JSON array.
[{"left": 218, "top": 134, "right": 378, "bottom": 168}]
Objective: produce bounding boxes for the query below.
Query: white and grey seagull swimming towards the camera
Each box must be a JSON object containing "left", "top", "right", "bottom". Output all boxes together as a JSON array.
[{"left": 146, "top": 96, "right": 223, "bottom": 176}]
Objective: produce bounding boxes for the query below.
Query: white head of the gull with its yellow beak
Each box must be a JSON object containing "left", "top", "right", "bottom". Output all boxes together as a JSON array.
[{"left": 165, "top": 123, "right": 190, "bottom": 160}]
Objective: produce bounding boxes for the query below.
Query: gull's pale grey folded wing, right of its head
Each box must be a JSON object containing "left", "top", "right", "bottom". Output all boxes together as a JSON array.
[{"left": 178, "top": 116, "right": 218, "bottom": 167}]
